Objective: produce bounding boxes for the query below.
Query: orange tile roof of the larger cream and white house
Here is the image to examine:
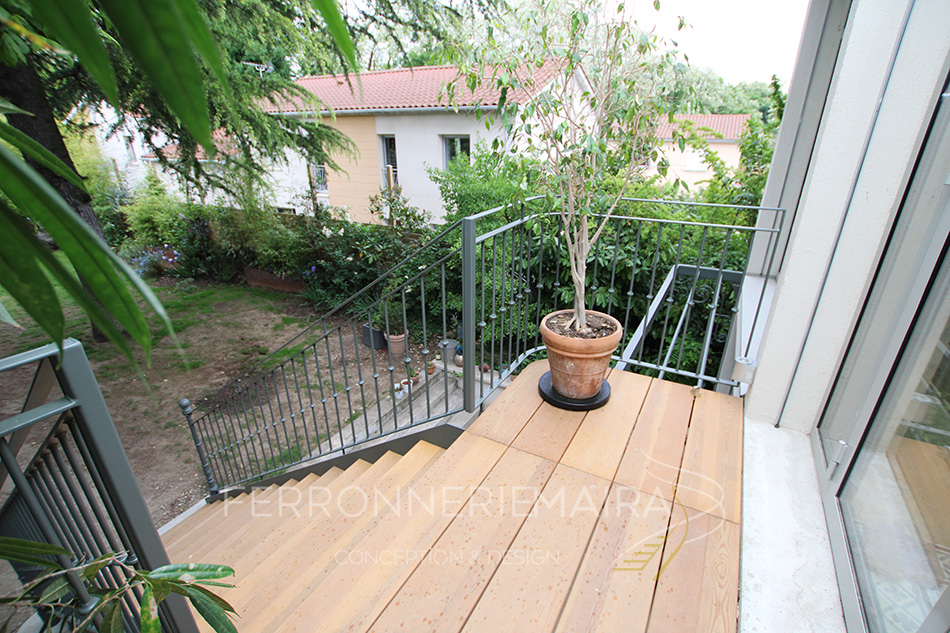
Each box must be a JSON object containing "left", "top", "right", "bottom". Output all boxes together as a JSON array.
[{"left": 262, "top": 63, "right": 557, "bottom": 113}]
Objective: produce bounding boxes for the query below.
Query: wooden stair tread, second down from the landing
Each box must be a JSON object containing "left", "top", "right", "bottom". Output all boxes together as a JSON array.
[{"left": 223, "top": 442, "right": 445, "bottom": 631}]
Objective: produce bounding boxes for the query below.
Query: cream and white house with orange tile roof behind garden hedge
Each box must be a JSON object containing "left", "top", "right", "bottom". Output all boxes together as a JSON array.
[{"left": 263, "top": 64, "right": 556, "bottom": 222}]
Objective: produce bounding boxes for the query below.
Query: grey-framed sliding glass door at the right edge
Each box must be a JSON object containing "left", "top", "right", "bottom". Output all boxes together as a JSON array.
[{"left": 813, "top": 81, "right": 950, "bottom": 633}]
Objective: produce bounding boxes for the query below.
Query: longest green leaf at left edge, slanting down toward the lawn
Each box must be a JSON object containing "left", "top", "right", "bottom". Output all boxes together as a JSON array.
[{"left": 0, "top": 146, "right": 151, "bottom": 356}]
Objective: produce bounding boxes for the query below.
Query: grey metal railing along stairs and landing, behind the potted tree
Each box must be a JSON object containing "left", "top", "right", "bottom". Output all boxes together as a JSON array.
[{"left": 183, "top": 197, "right": 784, "bottom": 492}]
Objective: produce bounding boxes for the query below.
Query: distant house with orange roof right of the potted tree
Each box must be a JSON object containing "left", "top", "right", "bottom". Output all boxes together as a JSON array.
[{"left": 645, "top": 114, "right": 752, "bottom": 191}]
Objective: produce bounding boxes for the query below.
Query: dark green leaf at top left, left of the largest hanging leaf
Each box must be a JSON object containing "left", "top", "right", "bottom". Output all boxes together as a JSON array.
[{"left": 36, "top": 0, "right": 119, "bottom": 105}]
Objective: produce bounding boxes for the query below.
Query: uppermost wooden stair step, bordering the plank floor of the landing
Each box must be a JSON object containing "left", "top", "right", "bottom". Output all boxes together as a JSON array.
[{"left": 264, "top": 433, "right": 505, "bottom": 633}]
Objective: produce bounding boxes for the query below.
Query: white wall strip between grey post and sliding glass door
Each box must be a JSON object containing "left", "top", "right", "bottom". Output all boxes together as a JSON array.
[{"left": 746, "top": 0, "right": 950, "bottom": 432}]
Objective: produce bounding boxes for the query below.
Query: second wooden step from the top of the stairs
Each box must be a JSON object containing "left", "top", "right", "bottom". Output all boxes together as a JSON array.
[{"left": 216, "top": 442, "right": 444, "bottom": 631}]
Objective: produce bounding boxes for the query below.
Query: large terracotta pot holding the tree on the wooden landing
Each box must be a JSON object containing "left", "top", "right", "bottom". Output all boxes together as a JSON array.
[{"left": 541, "top": 310, "right": 623, "bottom": 400}]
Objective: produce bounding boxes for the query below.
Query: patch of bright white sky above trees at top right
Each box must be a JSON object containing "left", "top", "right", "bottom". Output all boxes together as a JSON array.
[{"left": 626, "top": 0, "right": 808, "bottom": 87}]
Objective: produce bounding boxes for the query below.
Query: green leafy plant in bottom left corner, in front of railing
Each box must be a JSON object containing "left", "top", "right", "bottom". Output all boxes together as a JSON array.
[{"left": 0, "top": 537, "right": 237, "bottom": 633}]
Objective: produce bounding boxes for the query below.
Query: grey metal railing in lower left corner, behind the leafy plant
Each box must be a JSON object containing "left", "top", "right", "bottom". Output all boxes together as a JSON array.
[{"left": 0, "top": 339, "right": 198, "bottom": 633}]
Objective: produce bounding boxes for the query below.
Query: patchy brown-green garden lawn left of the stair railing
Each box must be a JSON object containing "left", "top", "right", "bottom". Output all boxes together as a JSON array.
[{"left": 0, "top": 259, "right": 315, "bottom": 526}]
